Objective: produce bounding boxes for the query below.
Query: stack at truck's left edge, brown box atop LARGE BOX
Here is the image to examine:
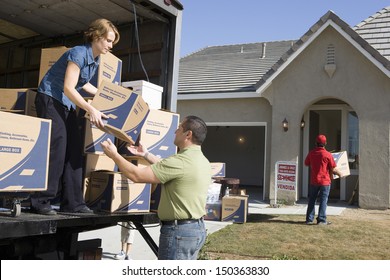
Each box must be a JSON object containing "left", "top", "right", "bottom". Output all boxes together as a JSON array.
[{"left": 0, "top": 47, "right": 61, "bottom": 192}]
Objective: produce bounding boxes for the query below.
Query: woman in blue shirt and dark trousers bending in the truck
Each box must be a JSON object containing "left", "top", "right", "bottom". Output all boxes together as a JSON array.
[{"left": 31, "top": 19, "right": 120, "bottom": 215}]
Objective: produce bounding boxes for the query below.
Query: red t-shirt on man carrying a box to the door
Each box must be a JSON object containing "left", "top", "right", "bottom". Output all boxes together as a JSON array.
[{"left": 305, "top": 147, "right": 336, "bottom": 186}]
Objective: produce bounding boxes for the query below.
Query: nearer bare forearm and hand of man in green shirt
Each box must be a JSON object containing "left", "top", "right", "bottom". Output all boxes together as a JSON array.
[{"left": 101, "top": 139, "right": 161, "bottom": 184}]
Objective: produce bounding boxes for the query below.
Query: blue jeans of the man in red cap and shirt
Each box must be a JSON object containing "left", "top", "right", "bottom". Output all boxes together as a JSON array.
[{"left": 306, "top": 185, "right": 330, "bottom": 223}]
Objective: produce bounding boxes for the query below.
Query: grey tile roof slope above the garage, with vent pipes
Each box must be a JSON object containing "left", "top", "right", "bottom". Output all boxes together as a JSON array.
[{"left": 178, "top": 41, "right": 294, "bottom": 94}]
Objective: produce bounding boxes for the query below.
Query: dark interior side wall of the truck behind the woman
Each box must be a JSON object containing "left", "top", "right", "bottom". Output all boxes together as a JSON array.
[{"left": 0, "top": 21, "right": 169, "bottom": 104}]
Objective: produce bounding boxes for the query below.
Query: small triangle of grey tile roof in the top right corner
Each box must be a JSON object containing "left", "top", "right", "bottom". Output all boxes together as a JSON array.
[{"left": 353, "top": 6, "right": 390, "bottom": 60}]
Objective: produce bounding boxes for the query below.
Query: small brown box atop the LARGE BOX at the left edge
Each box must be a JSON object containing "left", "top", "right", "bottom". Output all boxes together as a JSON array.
[{"left": 0, "top": 88, "right": 28, "bottom": 113}]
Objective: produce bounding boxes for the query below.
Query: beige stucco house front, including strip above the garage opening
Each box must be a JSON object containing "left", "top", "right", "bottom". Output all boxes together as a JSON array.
[{"left": 177, "top": 27, "right": 390, "bottom": 209}]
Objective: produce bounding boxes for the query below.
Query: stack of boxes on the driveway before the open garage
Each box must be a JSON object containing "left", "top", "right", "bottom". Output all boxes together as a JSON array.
[{"left": 205, "top": 162, "right": 248, "bottom": 223}]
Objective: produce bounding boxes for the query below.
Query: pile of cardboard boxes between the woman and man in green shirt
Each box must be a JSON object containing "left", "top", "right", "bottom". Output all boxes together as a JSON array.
[{"left": 84, "top": 75, "right": 179, "bottom": 212}]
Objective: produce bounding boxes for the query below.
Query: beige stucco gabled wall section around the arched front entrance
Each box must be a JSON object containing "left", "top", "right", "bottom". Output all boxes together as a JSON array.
[{"left": 264, "top": 27, "right": 390, "bottom": 208}]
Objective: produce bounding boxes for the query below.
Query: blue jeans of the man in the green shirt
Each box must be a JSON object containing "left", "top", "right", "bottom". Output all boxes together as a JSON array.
[{"left": 158, "top": 219, "right": 206, "bottom": 260}]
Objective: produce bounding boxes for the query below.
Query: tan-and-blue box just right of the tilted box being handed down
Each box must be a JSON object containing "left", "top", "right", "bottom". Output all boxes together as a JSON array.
[{"left": 117, "top": 109, "right": 179, "bottom": 158}]
